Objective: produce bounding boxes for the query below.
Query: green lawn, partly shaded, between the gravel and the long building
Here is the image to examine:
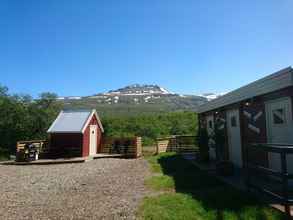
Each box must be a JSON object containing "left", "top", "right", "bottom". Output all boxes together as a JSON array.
[{"left": 138, "top": 153, "right": 285, "bottom": 220}]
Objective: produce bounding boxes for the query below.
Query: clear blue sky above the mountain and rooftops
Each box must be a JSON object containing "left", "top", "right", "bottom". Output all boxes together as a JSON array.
[{"left": 0, "top": 0, "right": 293, "bottom": 96}]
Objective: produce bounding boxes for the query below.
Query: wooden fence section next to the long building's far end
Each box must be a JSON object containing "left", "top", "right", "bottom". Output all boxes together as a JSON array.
[{"left": 156, "top": 135, "right": 198, "bottom": 154}]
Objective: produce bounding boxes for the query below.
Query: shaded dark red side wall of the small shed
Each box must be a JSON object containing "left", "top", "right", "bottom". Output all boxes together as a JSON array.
[{"left": 48, "top": 133, "right": 82, "bottom": 158}]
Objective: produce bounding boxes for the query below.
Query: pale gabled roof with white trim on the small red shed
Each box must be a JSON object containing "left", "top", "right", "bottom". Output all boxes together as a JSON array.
[{"left": 47, "top": 109, "right": 104, "bottom": 133}]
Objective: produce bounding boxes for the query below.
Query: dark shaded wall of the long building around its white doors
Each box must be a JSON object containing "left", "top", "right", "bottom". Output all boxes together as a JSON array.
[{"left": 199, "top": 87, "right": 293, "bottom": 166}]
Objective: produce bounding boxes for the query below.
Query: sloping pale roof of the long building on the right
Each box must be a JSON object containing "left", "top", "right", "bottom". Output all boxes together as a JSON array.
[{"left": 198, "top": 67, "right": 293, "bottom": 113}]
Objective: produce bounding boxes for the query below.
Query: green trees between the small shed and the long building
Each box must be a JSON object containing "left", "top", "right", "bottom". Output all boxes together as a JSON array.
[{"left": 102, "top": 112, "right": 197, "bottom": 145}]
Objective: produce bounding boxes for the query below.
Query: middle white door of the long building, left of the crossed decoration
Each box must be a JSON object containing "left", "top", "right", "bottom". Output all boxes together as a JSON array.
[{"left": 227, "top": 109, "right": 242, "bottom": 167}]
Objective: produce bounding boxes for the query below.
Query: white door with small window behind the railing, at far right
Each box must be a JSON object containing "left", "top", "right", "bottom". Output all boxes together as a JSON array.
[{"left": 266, "top": 97, "right": 293, "bottom": 172}]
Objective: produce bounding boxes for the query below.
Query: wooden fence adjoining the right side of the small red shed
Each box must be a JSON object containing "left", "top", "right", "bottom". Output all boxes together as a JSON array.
[{"left": 99, "top": 137, "right": 142, "bottom": 158}]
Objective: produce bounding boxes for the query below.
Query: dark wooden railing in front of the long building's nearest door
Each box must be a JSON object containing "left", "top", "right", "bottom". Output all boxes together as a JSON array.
[{"left": 244, "top": 143, "right": 293, "bottom": 216}]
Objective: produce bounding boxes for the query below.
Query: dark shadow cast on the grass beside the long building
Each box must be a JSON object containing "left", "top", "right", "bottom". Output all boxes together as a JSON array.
[{"left": 158, "top": 154, "right": 285, "bottom": 219}]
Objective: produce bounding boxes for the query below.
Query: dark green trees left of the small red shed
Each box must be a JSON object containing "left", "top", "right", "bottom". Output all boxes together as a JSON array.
[{"left": 0, "top": 86, "right": 62, "bottom": 155}]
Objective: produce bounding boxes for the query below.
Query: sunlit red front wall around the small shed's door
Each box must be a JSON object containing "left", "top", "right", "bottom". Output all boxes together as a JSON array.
[{"left": 82, "top": 115, "right": 102, "bottom": 157}]
